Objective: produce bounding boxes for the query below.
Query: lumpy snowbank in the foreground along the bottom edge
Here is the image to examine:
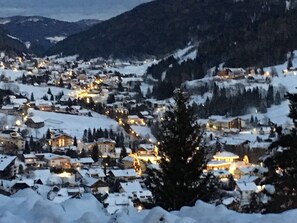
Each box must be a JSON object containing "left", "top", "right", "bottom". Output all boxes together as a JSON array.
[{"left": 0, "top": 189, "right": 297, "bottom": 223}]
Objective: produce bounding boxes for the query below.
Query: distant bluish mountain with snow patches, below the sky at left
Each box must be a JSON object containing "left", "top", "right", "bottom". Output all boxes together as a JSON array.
[{"left": 0, "top": 16, "right": 99, "bottom": 54}]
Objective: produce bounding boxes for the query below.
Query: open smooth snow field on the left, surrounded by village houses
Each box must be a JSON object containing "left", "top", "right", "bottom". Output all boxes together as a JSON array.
[{"left": 30, "top": 110, "right": 120, "bottom": 139}]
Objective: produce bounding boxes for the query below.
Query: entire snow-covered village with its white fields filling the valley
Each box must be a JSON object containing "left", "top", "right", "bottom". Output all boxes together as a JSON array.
[{"left": 0, "top": 47, "right": 297, "bottom": 222}]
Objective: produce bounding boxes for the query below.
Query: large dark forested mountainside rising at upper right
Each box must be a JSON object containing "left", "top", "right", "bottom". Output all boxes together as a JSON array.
[{"left": 49, "top": 0, "right": 297, "bottom": 66}]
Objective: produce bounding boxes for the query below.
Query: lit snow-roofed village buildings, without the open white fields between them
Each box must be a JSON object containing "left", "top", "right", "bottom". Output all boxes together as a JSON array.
[{"left": 0, "top": 52, "right": 284, "bottom": 213}]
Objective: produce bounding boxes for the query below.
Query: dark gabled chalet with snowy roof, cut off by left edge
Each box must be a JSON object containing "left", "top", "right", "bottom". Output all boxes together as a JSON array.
[{"left": 0, "top": 155, "right": 16, "bottom": 179}]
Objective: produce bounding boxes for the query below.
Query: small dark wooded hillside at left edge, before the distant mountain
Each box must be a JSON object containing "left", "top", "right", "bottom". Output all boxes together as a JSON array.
[{"left": 0, "top": 28, "right": 27, "bottom": 55}]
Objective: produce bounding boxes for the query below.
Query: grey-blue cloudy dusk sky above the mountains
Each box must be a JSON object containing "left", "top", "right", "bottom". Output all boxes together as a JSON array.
[{"left": 0, "top": 0, "right": 150, "bottom": 21}]
